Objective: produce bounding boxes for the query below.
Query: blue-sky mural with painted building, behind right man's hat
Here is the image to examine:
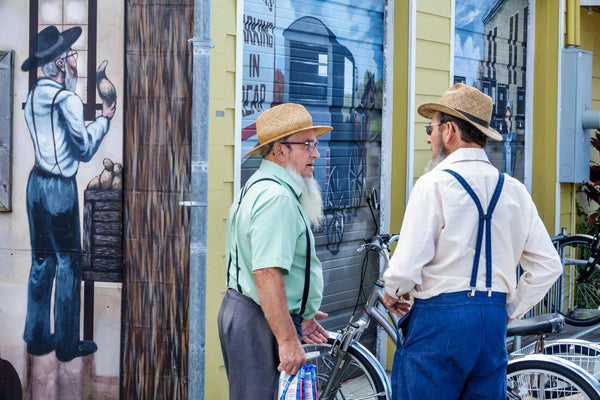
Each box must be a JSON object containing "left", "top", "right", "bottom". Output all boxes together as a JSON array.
[{"left": 454, "top": 0, "right": 529, "bottom": 181}]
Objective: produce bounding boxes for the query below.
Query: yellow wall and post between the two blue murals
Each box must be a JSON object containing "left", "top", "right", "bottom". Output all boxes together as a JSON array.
[{"left": 386, "top": 0, "right": 452, "bottom": 370}]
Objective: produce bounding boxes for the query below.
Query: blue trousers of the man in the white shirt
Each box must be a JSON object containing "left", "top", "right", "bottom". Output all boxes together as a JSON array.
[{"left": 392, "top": 292, "right": 508, "bottom": 400}]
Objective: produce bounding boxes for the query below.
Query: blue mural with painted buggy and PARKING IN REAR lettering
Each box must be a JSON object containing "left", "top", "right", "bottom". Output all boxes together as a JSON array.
[{"left": 240, "top": 0, "right": 384, "bottom": 344}]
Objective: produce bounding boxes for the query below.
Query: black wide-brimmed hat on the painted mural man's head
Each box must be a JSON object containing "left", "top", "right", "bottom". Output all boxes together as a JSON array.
[{"left": 21, "top": 25, "right": 82, "bottom": 71}]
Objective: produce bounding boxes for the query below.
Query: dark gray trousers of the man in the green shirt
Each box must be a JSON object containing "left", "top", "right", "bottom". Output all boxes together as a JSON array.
[{"left": 217, "top": 289, "right": 279, "bottom": 400}]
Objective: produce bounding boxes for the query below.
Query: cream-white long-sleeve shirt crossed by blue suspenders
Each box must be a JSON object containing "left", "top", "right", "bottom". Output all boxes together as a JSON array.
[{"left": 384, "top": 148, "right": 562, "bottom": 318}]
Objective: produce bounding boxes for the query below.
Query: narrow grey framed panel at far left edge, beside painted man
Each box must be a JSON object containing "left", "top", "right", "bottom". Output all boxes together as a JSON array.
[{"left": 0, "top": 50, "right": 15, "bottom": 211}]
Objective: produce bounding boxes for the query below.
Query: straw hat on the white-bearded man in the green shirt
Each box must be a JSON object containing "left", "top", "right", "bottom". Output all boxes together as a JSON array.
[{"left": 244, "top": 103, "right": 333, "bottom": 157}]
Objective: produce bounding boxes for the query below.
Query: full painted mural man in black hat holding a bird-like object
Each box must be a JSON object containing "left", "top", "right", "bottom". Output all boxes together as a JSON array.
[{"left": 21, "top": 26, "right": 115, "bottom": 362}]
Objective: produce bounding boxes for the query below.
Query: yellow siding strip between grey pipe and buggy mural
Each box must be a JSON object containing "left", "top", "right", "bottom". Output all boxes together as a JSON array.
[{"left": 204, "top": 0, "right": 237, "bottom": 400}]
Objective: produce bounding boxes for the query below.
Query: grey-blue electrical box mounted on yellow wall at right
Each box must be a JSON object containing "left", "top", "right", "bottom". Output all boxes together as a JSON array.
[{"left": 560, "top": 47, "right": 592, "bottom": 183}]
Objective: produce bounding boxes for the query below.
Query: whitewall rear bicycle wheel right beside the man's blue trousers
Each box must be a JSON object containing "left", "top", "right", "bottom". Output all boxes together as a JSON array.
[{"left": 506, "top": 355, "right": 600, "bottom": 400}]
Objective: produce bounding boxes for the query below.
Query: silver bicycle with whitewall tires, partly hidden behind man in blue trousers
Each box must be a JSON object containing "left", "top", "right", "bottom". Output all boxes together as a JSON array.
[{"left": 304, "top": 190, "right": 600, "bottom": 400}]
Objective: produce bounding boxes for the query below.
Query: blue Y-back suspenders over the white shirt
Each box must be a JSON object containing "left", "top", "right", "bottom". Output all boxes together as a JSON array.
[{"left": 444, "top": 169, "right": 504, "bottom": 297}]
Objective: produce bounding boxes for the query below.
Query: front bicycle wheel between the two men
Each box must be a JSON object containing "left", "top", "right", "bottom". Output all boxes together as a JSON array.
[{"left": 304, "top": 338, "right": 389, "bottom": 400}]
